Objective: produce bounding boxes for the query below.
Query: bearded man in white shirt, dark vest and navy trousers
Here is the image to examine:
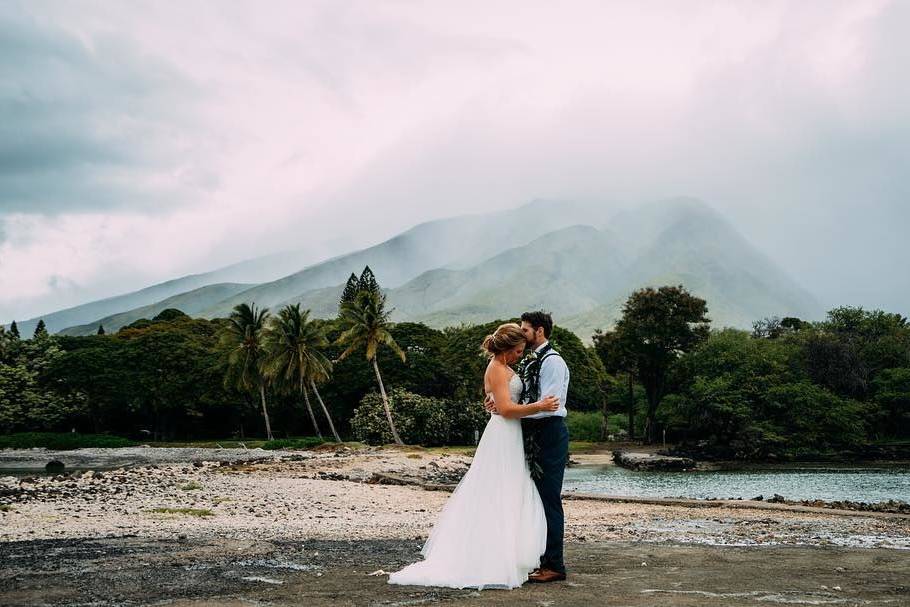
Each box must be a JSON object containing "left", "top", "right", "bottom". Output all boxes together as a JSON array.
[{"left": 486, "top": 312, "right": 569, "bottom": 583}]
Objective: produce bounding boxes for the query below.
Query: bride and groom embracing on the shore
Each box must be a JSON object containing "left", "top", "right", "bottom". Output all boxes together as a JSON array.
[{"left": 389, "top": 312, "right": 569, "bottom": 589}]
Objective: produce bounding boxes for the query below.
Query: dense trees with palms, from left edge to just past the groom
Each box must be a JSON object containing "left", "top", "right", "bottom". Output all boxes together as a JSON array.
[{"left": 0, "top": 268, "right": 607, "bottom": 443}]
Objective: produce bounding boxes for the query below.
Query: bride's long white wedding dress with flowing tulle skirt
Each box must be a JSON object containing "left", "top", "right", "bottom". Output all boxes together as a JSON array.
[{"left": 389, "top": 375, "right": 547, "bottom": 589}]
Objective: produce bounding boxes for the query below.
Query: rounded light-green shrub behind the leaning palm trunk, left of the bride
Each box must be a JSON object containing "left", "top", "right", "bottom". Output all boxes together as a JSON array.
[{"left": 351, "top": 389, "right": 489, "bottom": 447}]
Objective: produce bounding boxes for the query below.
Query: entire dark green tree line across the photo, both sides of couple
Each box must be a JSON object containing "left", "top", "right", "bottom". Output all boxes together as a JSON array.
[{"left": 0, "top": 276, "right": 910, "bottom": 458}]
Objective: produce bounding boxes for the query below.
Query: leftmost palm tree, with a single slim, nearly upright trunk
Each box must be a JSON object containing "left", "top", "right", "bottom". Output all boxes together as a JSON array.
[{"left": 220, "top": 303, "right": 272, "bottom": 440}]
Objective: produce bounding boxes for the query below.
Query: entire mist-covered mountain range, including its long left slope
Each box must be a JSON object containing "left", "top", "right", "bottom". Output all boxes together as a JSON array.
[{"left": 53, "top": 198, "right": 823, "bottom": 339}]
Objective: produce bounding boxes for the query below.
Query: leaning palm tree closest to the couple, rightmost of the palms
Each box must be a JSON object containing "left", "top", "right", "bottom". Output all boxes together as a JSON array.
[{"left": 338, "top": 289, "right": 405, "bottom": 445}]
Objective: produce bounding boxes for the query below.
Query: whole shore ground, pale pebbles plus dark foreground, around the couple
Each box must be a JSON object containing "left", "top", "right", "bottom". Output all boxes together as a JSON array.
[{"left": 0, "top": 447, "right": 910, "bottom": 605}]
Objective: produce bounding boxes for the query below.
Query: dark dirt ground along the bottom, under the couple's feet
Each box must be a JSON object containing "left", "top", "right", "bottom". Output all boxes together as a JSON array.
[{"left": 0, "top": 537, "right": 910, "bottom": 607}]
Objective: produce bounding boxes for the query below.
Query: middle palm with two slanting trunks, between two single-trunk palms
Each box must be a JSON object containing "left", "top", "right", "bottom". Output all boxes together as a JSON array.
[{"left": 265, "top": 304, "right": 341, "bottom": 443}]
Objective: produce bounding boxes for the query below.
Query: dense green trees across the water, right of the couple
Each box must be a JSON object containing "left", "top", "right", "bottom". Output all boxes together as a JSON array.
[{"left": 594, "top": 286, "right": 910, "bottom": 459}]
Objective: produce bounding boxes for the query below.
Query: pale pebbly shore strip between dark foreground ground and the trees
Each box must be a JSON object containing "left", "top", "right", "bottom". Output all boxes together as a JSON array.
[{"left": 0, "top": 446, "right": 910, "bottom": 549}]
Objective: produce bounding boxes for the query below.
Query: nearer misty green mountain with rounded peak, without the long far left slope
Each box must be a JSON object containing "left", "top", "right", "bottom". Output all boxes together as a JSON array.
[{"left": 282, "top": 199, "right": 821, "bottom": 339}]
